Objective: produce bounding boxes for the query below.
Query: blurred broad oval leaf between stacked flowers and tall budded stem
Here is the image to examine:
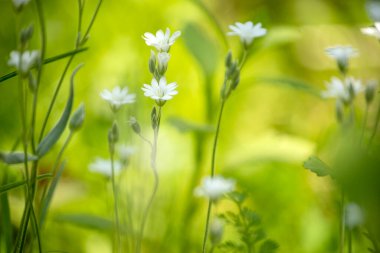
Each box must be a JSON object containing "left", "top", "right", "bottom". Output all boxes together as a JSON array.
[{"left": 183, "top": 23, "right": 218, "bottom": 76}]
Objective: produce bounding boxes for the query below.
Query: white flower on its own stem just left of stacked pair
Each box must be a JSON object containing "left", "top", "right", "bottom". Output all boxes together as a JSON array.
[{"left": 100, "top": 86, "right": 136, "bottom": 111}]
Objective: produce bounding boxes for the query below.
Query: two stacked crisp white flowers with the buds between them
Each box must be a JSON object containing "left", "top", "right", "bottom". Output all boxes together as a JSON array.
[{"left": 141, "top": 28, "right": 181, "bottom": 106}]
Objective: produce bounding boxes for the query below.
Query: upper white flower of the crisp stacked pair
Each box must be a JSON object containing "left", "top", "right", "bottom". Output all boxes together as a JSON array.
[{"left": 143, "top": 28, "right": 181, "bottom": 52}]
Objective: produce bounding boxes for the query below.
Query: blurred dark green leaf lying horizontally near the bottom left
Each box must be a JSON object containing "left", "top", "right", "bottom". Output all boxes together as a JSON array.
[{"left": 55, "top": 214, "right": 113, "bottom": 231}]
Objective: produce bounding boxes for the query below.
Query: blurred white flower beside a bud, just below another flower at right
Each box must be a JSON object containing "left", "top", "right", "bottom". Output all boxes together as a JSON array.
[{"left": 321, "top": 77, "right": 364, "bottom": 103}]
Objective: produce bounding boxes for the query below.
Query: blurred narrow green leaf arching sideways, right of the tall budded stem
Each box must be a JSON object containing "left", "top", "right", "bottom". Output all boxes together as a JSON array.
[{"left": 254, "top": 77, "right": 321, "bottom": 97}]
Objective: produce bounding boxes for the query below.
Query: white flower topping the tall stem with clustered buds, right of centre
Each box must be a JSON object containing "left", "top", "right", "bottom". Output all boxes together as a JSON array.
[{"left": 227, "top": 21, "right": 267, "bottom": 47}]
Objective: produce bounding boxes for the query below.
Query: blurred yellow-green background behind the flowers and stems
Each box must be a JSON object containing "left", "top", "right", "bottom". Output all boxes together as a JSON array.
[{"left": 0, "top": 0, "right": 380, "bottom": 253}]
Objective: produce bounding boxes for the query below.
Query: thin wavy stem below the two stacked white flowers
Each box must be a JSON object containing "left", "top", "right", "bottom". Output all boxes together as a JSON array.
[{"left": 136, "top": 106, "right": 162, "bottom": 253}]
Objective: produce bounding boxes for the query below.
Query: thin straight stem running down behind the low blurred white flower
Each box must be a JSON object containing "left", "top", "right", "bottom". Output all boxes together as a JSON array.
[{"left": 202, "top": 99, "right": 226, "bottom": 253}]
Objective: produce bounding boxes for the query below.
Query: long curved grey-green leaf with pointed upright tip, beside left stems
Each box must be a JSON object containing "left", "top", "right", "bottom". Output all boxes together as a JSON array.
[{"left": 36, "top": 65, "right": 82, "bottom": 157}]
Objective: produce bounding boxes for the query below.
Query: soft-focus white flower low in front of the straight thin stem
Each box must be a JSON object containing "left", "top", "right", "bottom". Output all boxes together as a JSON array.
[{"left": 194, "top": 176, "right": 235, "bottom": 201}]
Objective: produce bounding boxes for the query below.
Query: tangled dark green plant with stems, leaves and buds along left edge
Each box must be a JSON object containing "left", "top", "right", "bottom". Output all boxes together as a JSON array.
[{"left": 0, "top": 0, "right": 102, "bottom": 252}]
